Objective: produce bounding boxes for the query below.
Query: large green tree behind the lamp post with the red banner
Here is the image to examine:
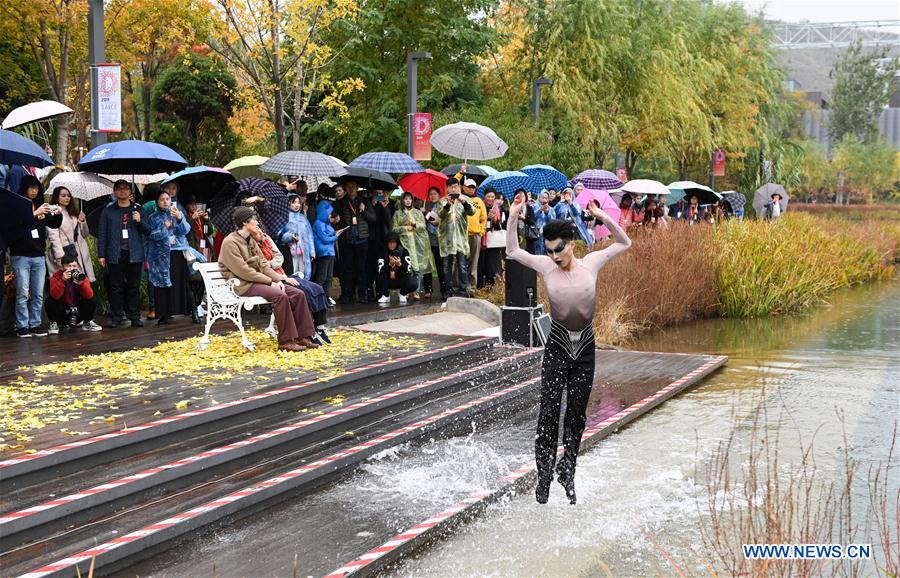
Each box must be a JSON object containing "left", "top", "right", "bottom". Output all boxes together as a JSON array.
[{"left": 304, "top": 0, "right": 498, "bottom": 160}]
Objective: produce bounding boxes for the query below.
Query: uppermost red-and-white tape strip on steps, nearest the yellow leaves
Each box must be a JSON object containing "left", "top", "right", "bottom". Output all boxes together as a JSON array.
[{"left": 0, "top": 338, "right": 490, "bottom": 470}]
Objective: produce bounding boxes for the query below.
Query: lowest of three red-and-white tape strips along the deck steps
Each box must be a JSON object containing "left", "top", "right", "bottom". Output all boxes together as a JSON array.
[{"left": 20, "top": 377, "right": 540, "bottom": 578}]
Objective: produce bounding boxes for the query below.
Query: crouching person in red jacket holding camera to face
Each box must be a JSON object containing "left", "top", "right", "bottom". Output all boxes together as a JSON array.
[{"left": 47, "top": 253, "right": 103, "bottom": 335}]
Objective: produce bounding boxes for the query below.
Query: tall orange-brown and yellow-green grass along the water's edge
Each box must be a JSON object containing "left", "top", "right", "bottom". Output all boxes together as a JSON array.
[{"left": 479, "top": 212, "right": 900, "bottom": 345}]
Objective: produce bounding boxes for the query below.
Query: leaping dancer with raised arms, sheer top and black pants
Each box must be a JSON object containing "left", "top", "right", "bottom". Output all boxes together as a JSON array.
[{"left": 506, "top": 194, "right": 631, "bottom": 504}]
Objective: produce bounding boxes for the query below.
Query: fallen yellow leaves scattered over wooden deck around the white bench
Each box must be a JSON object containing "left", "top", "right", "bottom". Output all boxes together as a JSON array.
[{"left": 0, "top": 329, "right": 427, "bottom": 452}]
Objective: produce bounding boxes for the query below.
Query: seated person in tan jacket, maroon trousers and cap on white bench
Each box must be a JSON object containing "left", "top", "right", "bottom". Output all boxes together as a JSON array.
[{"left": 219, "top": 207, "right": 318, "bottom": 351}]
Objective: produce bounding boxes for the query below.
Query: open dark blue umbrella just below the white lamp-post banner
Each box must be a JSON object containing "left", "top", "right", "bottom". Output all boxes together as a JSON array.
[{"left": 78, "top": 140, "right": 187, "bottom": 175}]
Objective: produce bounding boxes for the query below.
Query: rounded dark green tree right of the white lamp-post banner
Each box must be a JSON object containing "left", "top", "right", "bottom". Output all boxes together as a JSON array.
[{"left": 150, "top": 54, "right": 237, "bottom": 166}]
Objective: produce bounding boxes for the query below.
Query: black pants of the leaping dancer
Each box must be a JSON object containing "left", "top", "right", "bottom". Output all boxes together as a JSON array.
[{"left": 534, "top": 322, "right": 594, "bottom": 480}]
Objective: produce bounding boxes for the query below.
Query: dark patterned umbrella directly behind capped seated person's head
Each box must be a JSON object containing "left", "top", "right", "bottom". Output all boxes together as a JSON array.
[{"left": 209, "top": 177, "right": 290, "bottom": 235}]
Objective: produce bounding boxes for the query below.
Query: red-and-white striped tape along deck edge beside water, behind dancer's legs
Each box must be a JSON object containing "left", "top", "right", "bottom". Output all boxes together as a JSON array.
[{"left": 325, "top": 356, "right": 725, "bottom": 578}]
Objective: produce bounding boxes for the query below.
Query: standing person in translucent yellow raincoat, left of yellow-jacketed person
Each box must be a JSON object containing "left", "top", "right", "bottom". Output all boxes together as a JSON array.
[{"left": 438, "top": 177, "right": 475, "bottom": 298}]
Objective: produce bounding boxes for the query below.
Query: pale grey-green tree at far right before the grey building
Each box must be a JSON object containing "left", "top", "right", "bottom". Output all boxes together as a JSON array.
[{"left": 828, "top": 42, "right": 898, "bottom": 142}]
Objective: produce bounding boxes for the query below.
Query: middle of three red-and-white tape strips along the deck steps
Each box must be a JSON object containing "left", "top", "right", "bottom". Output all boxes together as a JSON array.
[{"left": 0, "top": 349, "right": 534, "bottom": 531}]
